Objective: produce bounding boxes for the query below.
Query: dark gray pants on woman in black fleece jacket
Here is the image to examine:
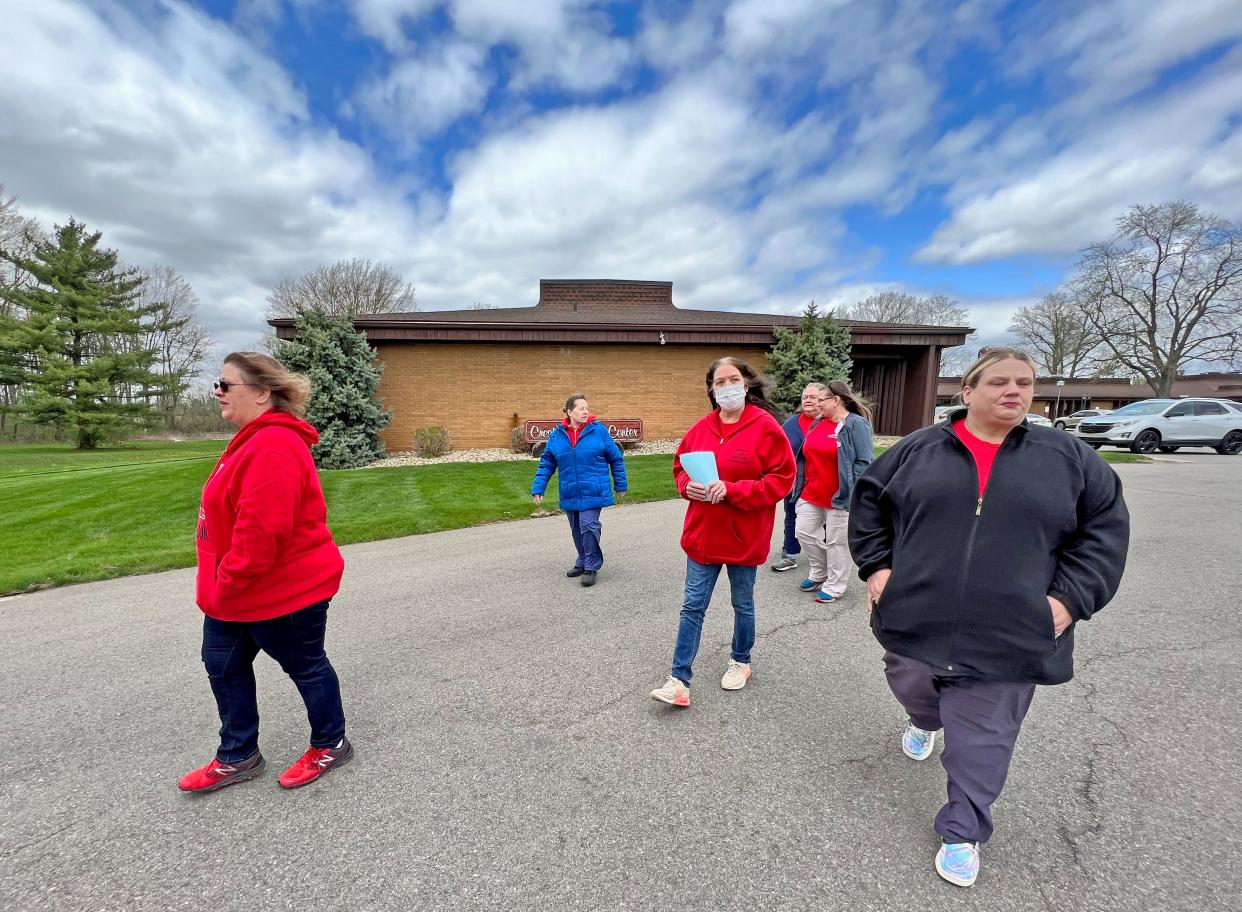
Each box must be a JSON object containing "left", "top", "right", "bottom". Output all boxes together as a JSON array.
[{"left": 884, "top": 652, "right": 1035, "bottom": 842}]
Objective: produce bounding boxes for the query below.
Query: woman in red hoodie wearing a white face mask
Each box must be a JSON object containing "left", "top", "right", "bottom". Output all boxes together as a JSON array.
[{"left": 651, "top": 358, "right": 796, "bottom": 706}]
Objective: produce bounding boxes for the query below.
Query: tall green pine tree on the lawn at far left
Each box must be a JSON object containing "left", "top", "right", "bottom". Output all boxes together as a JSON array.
[{"left": 0, "top": 219, "right": 176, "bottom": 450}]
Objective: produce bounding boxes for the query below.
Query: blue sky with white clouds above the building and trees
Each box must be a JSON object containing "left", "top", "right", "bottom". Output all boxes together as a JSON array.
[{"left": 0, "top": 0, "right": 1242, "bottom": 347}]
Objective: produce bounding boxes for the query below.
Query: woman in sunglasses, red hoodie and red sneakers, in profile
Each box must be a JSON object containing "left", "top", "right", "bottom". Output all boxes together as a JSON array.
[{"left": 179, "top": 352, "right": 354, "bottom": 791}]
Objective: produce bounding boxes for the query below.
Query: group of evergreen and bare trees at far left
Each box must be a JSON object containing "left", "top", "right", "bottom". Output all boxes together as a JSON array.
[{"left": 0, "top": 191, "right": 215, "bottom": 449}]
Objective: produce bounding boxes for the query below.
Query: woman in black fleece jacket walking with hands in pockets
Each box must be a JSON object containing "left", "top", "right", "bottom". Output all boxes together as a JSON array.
[{"left": 850, "top": 348, "right": 1129, "bottom": 886}]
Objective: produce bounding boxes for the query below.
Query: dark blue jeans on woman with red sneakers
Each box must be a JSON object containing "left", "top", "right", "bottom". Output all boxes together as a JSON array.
[{"left": 202, "top": 601, "right": 345, "bottom": 763}]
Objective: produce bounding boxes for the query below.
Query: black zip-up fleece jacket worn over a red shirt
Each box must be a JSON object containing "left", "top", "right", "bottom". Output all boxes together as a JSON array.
[{"left": 850, "top": 411, "right": 1130, "bottom": 683}]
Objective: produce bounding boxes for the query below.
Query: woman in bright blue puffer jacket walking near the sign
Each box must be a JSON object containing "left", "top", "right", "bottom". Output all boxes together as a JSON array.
[{"left": 530, "top": 393, "right": 628, "bottom": 585}]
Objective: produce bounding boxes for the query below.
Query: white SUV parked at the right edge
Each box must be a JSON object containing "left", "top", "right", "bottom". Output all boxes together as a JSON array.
[{"left": 1077, "top": 399, "right": 1242, "bottom": 456}]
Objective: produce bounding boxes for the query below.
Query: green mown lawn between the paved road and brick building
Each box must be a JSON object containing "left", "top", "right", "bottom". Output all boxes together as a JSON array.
[{"left": 0, "top": 440, "right": 1146, "bottom": 594}]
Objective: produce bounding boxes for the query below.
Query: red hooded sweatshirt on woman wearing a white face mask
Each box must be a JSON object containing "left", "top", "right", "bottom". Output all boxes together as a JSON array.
[{"left": 673, "top": 404, "right": 797, "bottom": 567}]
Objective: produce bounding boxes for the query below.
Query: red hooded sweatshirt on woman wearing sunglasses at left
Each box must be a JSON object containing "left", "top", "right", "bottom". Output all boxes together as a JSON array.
[{"left": 197, "top": 411, "right": 345, "bottom": 621}]
